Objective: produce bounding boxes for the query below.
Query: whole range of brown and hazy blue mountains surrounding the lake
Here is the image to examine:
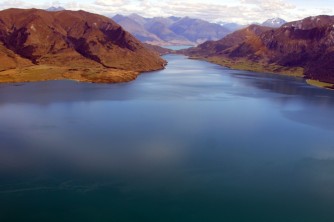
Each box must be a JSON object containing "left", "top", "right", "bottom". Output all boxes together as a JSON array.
[{"left": 0, "top": 8, "right": 334, "bottom": 84}]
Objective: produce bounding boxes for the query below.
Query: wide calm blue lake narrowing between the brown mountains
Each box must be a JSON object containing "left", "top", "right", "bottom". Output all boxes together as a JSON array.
[{"left": 0, "top": 55, "right": 334, "bottom": 222}]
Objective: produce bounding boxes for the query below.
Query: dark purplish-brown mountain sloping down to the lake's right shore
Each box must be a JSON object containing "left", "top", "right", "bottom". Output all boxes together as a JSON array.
[{"left": 183, "top": 15, "right": 334, "bottom": 84}]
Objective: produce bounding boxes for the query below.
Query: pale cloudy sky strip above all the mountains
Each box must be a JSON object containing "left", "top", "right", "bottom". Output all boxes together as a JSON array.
[{"left": 0, "top": 0, "right": 334, "bottom": 24}]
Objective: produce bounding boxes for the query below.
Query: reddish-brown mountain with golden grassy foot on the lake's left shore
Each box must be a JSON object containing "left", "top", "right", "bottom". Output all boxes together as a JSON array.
[{"left": 0, "top": 9, "right": 165, "bottom": 82}]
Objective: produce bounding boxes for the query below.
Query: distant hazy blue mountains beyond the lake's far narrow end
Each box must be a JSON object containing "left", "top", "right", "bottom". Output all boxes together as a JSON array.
[{"left": 113, "top": 14, "right": 231, "bottom": 45}]
